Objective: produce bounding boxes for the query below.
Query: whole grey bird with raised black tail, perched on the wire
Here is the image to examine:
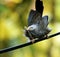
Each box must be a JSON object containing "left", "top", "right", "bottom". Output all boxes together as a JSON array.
[{"left": 25, "top": 0, "right": 51, "bottom": 43}]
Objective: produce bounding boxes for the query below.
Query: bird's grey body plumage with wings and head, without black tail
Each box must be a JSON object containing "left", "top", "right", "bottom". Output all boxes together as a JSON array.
[{"left": 27, "top": 10, "right": 50, "bottom": 38}]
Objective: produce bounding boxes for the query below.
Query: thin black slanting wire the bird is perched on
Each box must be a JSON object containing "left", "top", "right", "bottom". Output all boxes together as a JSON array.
[{"left": 0, "top": 32, "right": 60, "bottom": 54}]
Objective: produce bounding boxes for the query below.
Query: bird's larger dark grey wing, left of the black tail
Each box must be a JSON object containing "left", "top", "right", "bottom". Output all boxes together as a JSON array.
[{"left": 28, "top": 10, "right": 40, "bottom": 26}]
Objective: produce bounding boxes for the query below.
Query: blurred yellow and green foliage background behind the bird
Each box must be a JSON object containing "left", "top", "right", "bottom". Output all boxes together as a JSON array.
[{"left": 0, "top": 0, "right": 60, "bottom": 57}]
